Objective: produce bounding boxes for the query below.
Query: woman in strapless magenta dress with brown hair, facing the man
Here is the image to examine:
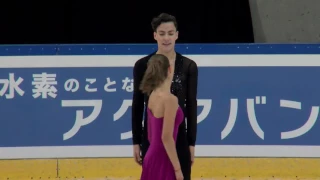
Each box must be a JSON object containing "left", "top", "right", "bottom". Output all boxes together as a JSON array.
[{"left": 140, "top": 54, "right": 184, "bottom": 180}]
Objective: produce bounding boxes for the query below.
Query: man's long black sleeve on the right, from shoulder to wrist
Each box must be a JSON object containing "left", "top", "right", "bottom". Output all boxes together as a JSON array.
[{"left": 186, "top": 60, "right": 198, "bottom": 146}]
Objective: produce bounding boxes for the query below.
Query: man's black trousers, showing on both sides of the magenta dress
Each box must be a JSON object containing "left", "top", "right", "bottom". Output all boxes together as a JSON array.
[{"left": 140, "top": 129, "right": 191, "bottom": 180}]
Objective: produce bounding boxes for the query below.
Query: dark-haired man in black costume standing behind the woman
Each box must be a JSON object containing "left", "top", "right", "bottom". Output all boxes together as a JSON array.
[{"left": 132, "top": 13, "right": 198, "bottom": 180}]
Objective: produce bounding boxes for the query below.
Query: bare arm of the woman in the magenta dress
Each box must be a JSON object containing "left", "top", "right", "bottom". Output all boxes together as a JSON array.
[{"left": 161, "top": 96, "right": 180, "bottom": 170}]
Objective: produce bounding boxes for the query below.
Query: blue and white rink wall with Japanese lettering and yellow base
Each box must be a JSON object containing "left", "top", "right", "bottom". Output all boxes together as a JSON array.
[{"left": 0, "top": 44, "right": 320, "bottom": 180}]
